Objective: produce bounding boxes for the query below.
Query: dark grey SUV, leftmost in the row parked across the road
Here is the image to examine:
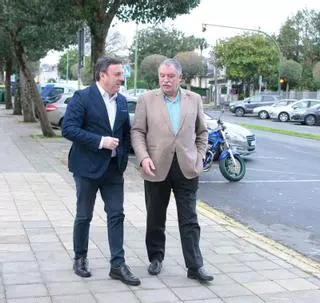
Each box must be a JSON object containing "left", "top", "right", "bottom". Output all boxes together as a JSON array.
[{"left": 229, "top": 95, "right": 279, "bottom": 117}]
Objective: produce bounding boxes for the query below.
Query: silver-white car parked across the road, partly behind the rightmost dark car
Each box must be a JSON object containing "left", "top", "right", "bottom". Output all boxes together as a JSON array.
[{"left": 270, "top": 99, "right": 320, "bottom": 122}]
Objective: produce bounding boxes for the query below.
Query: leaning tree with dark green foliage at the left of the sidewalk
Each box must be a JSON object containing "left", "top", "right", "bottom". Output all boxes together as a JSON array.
[{"left": 0, "top": 0, "right": 78, "bottom": 136}]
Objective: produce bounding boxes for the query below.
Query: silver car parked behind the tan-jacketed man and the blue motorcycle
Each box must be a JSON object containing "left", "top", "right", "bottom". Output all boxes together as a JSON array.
[{"left": 127, "top": 97, "right": 256, "bottom": 156}]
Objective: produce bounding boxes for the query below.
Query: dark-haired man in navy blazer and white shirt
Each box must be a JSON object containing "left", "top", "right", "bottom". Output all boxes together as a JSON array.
[{"left": 62, "top": 57, "right": 140, "bottom": 285}]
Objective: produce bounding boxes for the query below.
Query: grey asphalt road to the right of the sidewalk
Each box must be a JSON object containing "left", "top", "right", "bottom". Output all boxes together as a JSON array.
[{"left": 198, "top": 113, "right": 320, "bottom": 261}]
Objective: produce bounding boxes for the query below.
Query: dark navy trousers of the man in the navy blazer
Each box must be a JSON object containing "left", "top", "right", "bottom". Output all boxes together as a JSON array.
[{"left": 73, "top": 158, "right": 124, "bottom": 267}]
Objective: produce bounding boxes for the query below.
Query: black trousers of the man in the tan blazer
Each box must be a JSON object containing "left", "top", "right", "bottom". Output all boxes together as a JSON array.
[{"left": 144, "top": 156, "right": 203, "bottom": 269}]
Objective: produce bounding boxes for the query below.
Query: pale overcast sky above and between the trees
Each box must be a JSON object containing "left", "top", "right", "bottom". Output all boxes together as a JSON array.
[{"left": 41, "top": 0, "right": 320, "bottom": 64}]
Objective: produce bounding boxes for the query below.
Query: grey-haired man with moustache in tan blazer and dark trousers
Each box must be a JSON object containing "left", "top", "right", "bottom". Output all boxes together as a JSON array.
[{"left": 131, "top": 59, "right": 213, "bottom": 282}]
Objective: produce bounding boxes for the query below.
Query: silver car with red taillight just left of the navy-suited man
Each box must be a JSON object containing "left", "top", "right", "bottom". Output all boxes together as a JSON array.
[{"left": 46, "top": 93, "right": 73, "bottom": 127}]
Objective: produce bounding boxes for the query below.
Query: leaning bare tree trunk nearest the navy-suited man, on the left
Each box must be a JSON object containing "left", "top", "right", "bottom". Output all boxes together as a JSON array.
[{"left": 10, "top": 31, "right": 55, "bottom": 137}]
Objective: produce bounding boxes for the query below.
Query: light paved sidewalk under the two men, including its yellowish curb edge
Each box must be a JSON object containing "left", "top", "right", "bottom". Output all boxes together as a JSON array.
[{"left": 0, "top": 105, "right": 320, "bottom": 303}]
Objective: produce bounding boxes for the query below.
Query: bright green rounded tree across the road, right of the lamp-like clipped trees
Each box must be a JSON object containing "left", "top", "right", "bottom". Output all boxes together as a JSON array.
[{"left": 213, "top": 34, "right": 279, "bottom": 89}]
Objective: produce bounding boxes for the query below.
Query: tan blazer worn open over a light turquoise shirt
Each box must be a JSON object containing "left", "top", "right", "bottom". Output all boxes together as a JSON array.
[{"left": 131, "top": 89, "right": 208, "bottom": 181}]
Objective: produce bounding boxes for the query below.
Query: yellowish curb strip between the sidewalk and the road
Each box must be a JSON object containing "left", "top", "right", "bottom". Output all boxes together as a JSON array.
[{"left": 197, "top": 200, "right": 320, "bottom": 278}]
